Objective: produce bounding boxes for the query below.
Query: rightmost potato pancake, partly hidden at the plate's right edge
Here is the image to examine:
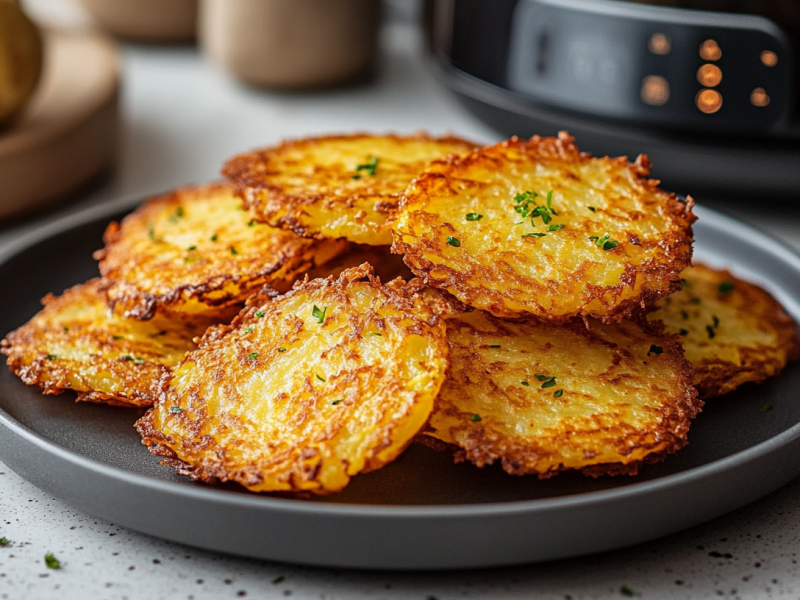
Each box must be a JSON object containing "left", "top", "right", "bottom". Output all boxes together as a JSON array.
[{"left": 648, "top": 264, "right": 800, "bottom": 398}]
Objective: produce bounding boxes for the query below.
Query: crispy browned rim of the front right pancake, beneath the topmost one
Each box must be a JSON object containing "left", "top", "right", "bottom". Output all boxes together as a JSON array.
[{"left": 414, "top": 304, "right": 704, "bottom": 479}]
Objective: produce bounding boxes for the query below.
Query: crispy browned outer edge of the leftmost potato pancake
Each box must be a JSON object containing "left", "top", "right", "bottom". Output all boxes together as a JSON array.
[{"left": 0, "top": 283, "right": 164, "bottom": 408}]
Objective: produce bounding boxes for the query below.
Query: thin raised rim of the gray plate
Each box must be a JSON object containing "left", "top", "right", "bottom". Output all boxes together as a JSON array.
[{"left": 0, "top": 195, "right": 800, "bottom": 520}]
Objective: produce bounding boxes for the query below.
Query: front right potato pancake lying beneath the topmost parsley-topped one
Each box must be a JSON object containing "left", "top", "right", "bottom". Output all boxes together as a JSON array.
[{"left": 424, "top": 311, "right": 702, "bottom": 477}]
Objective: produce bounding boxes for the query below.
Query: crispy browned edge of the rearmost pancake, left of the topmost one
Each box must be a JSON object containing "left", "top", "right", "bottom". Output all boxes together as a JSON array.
[{"left": 222, "top": 132, "right": 478, "bottom": 239}]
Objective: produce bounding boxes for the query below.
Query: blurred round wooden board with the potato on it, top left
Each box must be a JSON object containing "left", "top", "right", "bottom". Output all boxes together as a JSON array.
[{"left": 0, "top": 0, "right": 120, "bottom": 219}]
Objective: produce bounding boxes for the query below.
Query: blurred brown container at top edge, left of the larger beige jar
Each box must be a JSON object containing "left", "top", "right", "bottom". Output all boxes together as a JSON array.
[{"left": 81, "top": 0, "right": 198, "bottom": 43}]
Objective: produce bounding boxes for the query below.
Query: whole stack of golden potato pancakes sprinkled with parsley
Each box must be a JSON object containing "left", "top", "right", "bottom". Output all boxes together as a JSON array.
[{"left": 2, "top": 133, "right": 798, "bottom": 494}]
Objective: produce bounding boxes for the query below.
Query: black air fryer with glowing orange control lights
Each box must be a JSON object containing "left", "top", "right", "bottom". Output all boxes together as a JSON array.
[{"left": 429, "top": 0, "right": 800, "bottom": 199}]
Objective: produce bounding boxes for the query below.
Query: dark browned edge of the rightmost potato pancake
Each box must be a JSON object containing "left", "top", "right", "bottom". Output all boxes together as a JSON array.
[{"left": 694, "top": 265, "right": 800, "bottom": 398}]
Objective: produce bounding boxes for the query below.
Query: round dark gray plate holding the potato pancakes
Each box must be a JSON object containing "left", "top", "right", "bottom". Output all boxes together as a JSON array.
[{"left": 0, "top": 203, "right": 800, "bottom": 569}]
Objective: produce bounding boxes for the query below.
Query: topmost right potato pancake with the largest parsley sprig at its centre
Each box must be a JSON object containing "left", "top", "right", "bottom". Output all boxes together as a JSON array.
[{"left": 391, "top": 132, "right": 695, "bottom": 322}]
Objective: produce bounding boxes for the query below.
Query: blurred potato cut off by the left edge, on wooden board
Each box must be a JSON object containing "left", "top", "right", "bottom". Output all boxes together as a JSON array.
[{"left": 0, "top": 0, "right": 42, "bottom": 126}]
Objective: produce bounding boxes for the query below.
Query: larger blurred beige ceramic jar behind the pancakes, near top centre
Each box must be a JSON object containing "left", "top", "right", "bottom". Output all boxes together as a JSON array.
[{"left": 200, "top": 0, "right": 380, "bottom": 89}]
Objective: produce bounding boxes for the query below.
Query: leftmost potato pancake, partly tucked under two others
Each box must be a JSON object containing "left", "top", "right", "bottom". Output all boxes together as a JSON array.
[{"left": 2, "top": 279, "right": 211, "bottom": 406}]
